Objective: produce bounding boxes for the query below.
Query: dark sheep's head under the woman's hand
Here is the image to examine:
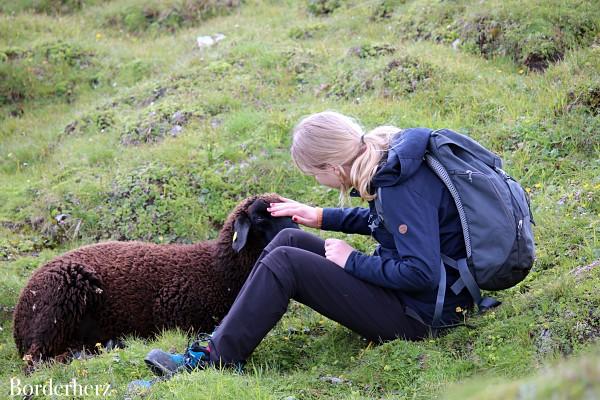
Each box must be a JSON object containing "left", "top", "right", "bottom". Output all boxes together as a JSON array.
[{"left": 232, "top": 194, "right": 298, "bottom": 253}]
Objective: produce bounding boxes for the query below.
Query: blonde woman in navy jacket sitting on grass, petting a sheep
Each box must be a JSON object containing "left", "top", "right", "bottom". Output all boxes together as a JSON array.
[{"left": 145, "top": 111, "right": 473, "bottom": 375}]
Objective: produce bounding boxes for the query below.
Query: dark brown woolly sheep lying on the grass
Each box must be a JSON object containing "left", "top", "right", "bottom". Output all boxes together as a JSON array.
[{"left": 14, "top": 194, "right": 298, "bottom": 364}]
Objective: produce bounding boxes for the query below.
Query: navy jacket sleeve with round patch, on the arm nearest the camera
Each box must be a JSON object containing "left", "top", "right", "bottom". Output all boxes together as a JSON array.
[{"left": 344, "top": 185, "right": 440, "bottom": 292}]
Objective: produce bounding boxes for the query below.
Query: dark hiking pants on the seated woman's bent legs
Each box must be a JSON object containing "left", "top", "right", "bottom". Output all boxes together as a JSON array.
[{"left": 210, "top": 229, "right": 429, "bottom": 364}]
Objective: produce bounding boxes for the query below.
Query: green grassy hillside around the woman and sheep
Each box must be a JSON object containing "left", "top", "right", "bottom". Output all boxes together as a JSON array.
[{"left": 0, "top": 0, "right": 600, "bottom": 399}]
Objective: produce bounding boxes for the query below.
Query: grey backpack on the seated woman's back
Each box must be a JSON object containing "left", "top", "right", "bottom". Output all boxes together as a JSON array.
[{"left": 376, "top": 129, "right": 535, "bottom": 328}]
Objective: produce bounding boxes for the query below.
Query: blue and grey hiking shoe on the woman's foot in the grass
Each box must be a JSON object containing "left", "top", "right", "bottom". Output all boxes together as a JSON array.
[{"left": 144, "top": 339, "right": 210, "bottom": 376}]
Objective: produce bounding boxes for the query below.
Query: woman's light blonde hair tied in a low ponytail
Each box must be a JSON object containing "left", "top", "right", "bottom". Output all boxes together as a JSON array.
[{"left": 291, "top": 110, "right": 400, "bottom": 204}]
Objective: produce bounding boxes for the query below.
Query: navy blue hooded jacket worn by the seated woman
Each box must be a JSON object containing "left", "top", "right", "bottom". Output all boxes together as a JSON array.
[{"left": 322, "top": 128, "right": 473, "bottom": 324}]
